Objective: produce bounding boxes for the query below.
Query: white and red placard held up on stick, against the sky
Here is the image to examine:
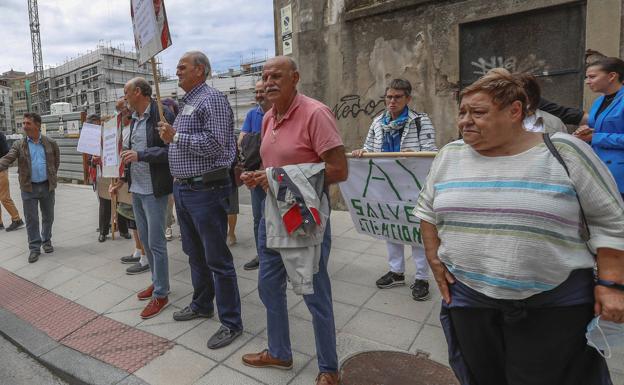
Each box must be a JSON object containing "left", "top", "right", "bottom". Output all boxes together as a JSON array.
[{"left": 130, "top": 0, "right": 171, "bottom": 65}]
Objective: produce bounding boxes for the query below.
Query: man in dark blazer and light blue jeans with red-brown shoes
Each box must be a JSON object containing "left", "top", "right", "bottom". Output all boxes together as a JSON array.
[{"left": 113, "top": 78, "right": 173, "bottom": 319}]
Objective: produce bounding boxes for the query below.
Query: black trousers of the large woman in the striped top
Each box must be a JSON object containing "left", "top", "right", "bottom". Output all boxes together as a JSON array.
[{"left": 450, "top": 304, "right": 604, "bottom": 385}]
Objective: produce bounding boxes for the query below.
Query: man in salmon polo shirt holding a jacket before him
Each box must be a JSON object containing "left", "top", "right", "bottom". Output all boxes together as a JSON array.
[{"left": 241, "top": 56, "right": 348, "bottom": 385}]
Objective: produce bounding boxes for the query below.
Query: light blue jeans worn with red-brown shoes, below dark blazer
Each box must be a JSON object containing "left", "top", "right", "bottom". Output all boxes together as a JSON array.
[{"left": 132, "top": 193, "right": 169, "bottom": 298}]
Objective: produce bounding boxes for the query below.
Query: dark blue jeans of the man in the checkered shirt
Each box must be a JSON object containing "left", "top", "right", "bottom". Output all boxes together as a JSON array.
[{"left": 173, "top": 182, "right": 243, "bottom": 330}]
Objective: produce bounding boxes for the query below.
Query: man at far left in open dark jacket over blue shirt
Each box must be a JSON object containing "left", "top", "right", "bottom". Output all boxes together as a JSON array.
[{"left": 0, "top": 113, "right": 61, "bottom": 263}]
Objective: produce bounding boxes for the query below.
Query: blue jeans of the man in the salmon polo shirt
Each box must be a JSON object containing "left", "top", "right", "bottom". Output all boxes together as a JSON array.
[{"left": 258, "top": 204, "right": 338, "bottom": 372}]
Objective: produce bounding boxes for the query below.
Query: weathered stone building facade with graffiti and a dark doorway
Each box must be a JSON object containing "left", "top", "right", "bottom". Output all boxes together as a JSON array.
[{"left": 274, "top": 0, "right": 623, "bottom": 149}]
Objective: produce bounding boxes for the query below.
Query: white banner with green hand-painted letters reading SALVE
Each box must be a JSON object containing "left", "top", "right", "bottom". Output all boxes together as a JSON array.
[{"left": 340, "top": 156, "right": 433, "bottom": 247}]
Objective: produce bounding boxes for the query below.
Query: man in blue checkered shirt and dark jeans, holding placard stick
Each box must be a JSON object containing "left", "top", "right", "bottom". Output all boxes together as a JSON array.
[{"left": 160, "top": 51, "right": 243, "bottom": 349}]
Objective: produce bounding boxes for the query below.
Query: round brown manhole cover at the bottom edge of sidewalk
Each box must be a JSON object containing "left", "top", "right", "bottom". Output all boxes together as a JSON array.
[{"left": 341, "top": 351, "right": 459, "bottom": 385}]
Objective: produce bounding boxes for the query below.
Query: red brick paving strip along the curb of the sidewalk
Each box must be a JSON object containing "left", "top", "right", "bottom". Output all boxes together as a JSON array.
[{"left": 0, "top": 268, "right": 174, "bottom": 373}]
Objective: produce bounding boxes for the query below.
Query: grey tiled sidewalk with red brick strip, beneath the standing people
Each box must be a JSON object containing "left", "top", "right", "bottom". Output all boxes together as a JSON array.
[{"left": 0, "top": 171, "right": 624, "bottom": 385}]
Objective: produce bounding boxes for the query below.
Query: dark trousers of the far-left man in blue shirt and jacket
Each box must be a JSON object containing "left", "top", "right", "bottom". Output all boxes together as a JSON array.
[{"left": 22, "top": 182, "right": 54, "bottom": 252}]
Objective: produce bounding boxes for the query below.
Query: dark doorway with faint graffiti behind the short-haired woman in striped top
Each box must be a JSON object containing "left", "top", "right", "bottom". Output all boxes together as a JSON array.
[{"left": 460, "top": 2, "right": 585, "bottom": 108}]
